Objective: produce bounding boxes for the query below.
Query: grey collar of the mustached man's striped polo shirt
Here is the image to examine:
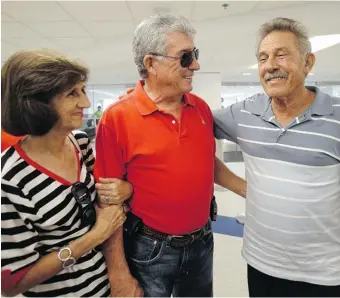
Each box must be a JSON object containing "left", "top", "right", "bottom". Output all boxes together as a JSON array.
[{"left": 248, "top": 86, "right": 333, "bottom": 120}]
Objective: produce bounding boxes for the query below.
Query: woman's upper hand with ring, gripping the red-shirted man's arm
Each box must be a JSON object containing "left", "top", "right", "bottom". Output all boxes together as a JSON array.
[{"left": 96, "top": 178, "right": 133, "bottom": 205}]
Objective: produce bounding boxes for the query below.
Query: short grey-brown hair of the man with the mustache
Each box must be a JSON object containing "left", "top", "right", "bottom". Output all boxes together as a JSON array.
[{"left": 256, "top": 18, "right": 312, "bottom": 58}]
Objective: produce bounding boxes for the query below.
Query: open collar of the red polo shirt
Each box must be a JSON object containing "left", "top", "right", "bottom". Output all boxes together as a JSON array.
[{"left": 131, "top": 80, "right": 195, "bottom": 116}]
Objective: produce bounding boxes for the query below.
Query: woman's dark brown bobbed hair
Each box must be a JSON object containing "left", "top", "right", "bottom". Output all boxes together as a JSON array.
[{"left": 1, "top": 50, "right": 89, "bottom": 136}]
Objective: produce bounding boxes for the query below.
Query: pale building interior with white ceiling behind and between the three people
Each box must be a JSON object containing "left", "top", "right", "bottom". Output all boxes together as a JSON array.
[{"left": 1, "top": 1, "right": 340, "bottom": 297}]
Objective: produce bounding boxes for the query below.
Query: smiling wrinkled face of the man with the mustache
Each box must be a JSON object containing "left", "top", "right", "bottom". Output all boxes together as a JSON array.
[{"left": 258, "top": 31, "right": 310, "bottom": 98}]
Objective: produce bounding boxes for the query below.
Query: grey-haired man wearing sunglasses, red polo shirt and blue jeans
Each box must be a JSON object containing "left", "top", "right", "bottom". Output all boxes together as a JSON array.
[{"left": 95, "top": 15, "right": 245, "bottom": 297}]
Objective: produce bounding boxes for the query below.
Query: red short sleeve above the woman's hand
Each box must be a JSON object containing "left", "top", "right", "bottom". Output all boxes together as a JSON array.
[{"left": 94, "top": 121, "right": 126, "bottom": 181}]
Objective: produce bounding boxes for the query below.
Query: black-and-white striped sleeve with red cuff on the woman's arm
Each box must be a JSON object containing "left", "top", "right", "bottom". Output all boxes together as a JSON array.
[{"left": 1, "top": 179, "right": 40, "bottom": 289}]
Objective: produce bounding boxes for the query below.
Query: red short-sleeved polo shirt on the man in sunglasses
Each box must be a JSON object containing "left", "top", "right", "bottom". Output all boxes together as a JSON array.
[{"left": 94, "top": 81, "right": 215, "bottom": 235}]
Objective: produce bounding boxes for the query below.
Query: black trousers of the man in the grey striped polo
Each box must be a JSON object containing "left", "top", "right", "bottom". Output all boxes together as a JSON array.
[{"left": 248, "top": 265, "right": 340, "bottom": 297}]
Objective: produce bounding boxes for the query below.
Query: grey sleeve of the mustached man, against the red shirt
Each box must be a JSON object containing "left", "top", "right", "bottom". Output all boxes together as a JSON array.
[{"left": 213, "top": 104, "right": 238, "bottom": 143}]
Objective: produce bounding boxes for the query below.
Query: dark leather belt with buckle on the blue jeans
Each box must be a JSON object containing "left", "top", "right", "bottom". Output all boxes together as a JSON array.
[{"left": 139, "top": 222, "right": 211, "bottom": 247}]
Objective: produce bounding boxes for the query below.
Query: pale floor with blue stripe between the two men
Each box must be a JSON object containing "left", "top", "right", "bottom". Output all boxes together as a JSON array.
[{"left": 214, "top": 163, "right": 248, "bottom": 297}]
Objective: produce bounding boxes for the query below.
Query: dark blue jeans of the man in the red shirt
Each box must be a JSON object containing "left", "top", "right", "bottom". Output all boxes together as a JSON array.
[{"left": 124, "top": 219, "right": 214, "bottom": 297}]
